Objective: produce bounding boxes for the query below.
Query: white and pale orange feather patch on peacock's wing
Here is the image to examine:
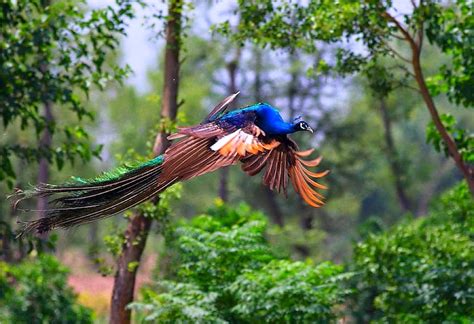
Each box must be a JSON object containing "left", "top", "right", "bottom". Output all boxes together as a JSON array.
[{"left": 211, "top": 129, "right": 280, "bottom": 156}]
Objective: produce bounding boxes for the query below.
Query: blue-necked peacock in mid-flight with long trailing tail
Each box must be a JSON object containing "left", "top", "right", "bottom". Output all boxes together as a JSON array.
[{"left": 13, "top": 93, "right": 329, "bottom": 235}]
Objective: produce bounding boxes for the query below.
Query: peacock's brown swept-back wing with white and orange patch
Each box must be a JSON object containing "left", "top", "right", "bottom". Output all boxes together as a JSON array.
[{"left": 166, "top": 104, "right": 280, "bottom": 181}]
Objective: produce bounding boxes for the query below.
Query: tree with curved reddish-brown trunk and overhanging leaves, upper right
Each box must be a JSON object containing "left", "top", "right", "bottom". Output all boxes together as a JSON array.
[{"left": 220, "top": 0, "right": 474, "bottom": 195}]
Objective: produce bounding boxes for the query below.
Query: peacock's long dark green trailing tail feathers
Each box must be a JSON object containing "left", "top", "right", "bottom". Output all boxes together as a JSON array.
[{"left": 13, "top": 156, "right": 168, "bottom": 236}]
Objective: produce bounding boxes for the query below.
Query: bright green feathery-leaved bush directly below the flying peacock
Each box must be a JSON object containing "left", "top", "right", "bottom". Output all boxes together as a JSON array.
[{"left": 130, "top": 203, "right": 347, "bottom": 323}]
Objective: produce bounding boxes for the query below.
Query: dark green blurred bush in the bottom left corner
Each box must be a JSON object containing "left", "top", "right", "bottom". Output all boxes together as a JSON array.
[{"left": 0, "top": 255, "right": 92, "bottom": 323}]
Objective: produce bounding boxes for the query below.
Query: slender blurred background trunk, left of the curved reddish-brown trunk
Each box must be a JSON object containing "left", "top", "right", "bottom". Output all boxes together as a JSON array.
[{"left": 379, "top": 98, "right": 413, "bottom": 212}]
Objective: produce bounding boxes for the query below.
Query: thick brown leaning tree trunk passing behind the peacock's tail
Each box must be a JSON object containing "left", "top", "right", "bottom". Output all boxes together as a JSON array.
[{"left": 110, "top": 0, "right": 183, "bottom": 324}]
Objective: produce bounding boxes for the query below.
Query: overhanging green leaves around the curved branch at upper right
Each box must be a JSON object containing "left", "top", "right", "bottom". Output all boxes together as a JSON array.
[{"left": 226, "top": 0, "right": 474, "bottom": 107}]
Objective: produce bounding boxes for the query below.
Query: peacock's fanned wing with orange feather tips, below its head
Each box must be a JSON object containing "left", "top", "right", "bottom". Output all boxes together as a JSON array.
[{"left": 242, "top": 138, "right": 329, "bottom": 207}]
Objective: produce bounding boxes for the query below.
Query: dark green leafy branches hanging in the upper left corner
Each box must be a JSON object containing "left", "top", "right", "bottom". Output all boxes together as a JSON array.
[{"left": 0, "top": 0, "right": 133, "bottom": 186}]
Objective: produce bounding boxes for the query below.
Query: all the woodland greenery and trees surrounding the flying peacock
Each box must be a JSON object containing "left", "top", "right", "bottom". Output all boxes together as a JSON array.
[{"left": 0, "top": 0, "right": 474, "bottom": 323}]
